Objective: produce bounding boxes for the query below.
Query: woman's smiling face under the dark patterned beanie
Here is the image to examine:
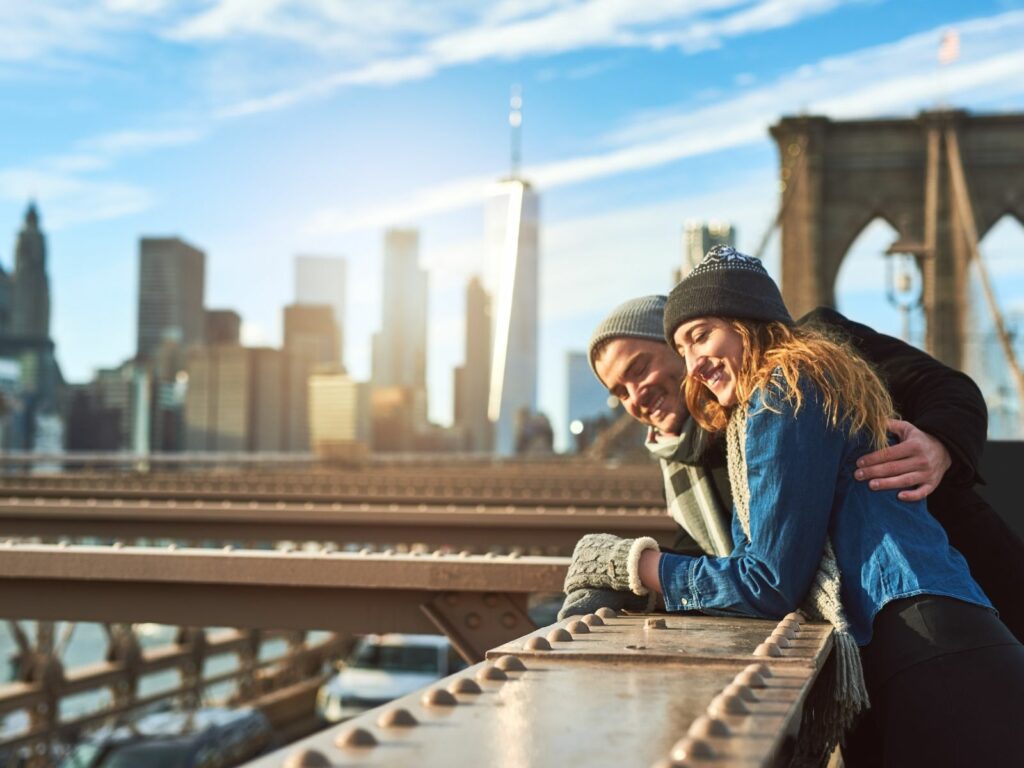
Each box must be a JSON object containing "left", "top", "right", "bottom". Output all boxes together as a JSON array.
[{"left": 672, "top": 317, "right": 743, "bottom": 407}]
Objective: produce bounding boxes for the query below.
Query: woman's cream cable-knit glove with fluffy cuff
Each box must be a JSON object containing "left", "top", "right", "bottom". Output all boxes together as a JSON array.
[{"left": 564, "top": 534, "right": 658, "bottom": 596}]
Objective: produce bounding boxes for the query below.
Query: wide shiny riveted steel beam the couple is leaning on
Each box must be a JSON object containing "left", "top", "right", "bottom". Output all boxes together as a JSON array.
[{"left": 247, "top": 609, "right": 831, "bottom": 768}]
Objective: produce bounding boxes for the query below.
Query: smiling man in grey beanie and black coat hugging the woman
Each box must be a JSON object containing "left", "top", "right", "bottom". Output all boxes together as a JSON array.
[{"left": 561, "top": 296, "right": 1024, "bottom": 639}]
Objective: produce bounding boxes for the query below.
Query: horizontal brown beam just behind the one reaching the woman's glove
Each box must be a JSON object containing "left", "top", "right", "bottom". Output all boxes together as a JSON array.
[{"left": 0, "top": 499, "right": 676, "bottom": 550}]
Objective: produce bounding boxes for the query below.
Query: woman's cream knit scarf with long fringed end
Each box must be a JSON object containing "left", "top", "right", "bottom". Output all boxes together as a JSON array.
[{"left": 726, "top": 404, "right": 869, "bottom": 764}]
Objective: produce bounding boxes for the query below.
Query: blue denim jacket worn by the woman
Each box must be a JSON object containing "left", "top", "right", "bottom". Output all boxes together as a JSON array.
[{"left": 658, "top": 376, "right": 991, "bottom": 645}]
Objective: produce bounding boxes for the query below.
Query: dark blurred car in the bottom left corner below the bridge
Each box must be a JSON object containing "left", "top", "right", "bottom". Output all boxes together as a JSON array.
[{"left": 60, "top": 708, "right": 273, "bottom": 768}]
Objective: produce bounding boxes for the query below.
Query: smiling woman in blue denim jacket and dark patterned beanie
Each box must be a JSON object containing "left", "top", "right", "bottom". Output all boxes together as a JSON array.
[{"left": 566, "top": 248, "right": 1024, "bottom": 766}]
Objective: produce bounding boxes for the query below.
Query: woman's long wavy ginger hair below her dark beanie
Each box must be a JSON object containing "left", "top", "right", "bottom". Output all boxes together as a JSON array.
[{"left": 684, "top": 318, "right": 894, "bottom": 449}]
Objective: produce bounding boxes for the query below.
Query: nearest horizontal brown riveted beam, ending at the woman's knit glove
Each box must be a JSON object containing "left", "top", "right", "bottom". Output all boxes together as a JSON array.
[{"left": 0, "top": 543, "right": 568, "bottom": 636}]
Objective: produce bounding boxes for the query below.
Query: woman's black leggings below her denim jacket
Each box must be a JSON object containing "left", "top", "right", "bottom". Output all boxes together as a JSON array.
[{"left": 843, "top": 598, "right": 1024, "bottom": 768}]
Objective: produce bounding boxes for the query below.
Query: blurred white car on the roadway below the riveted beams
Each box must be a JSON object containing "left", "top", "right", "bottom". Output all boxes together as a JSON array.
[{"left": 316, "top": 634, "right": 466, "bottom": 723}]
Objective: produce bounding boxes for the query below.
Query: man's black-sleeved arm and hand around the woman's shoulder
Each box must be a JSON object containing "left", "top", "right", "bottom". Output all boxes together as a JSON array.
[{"left": 800, "top": 307, "right": 988, "bottom": 498}]
